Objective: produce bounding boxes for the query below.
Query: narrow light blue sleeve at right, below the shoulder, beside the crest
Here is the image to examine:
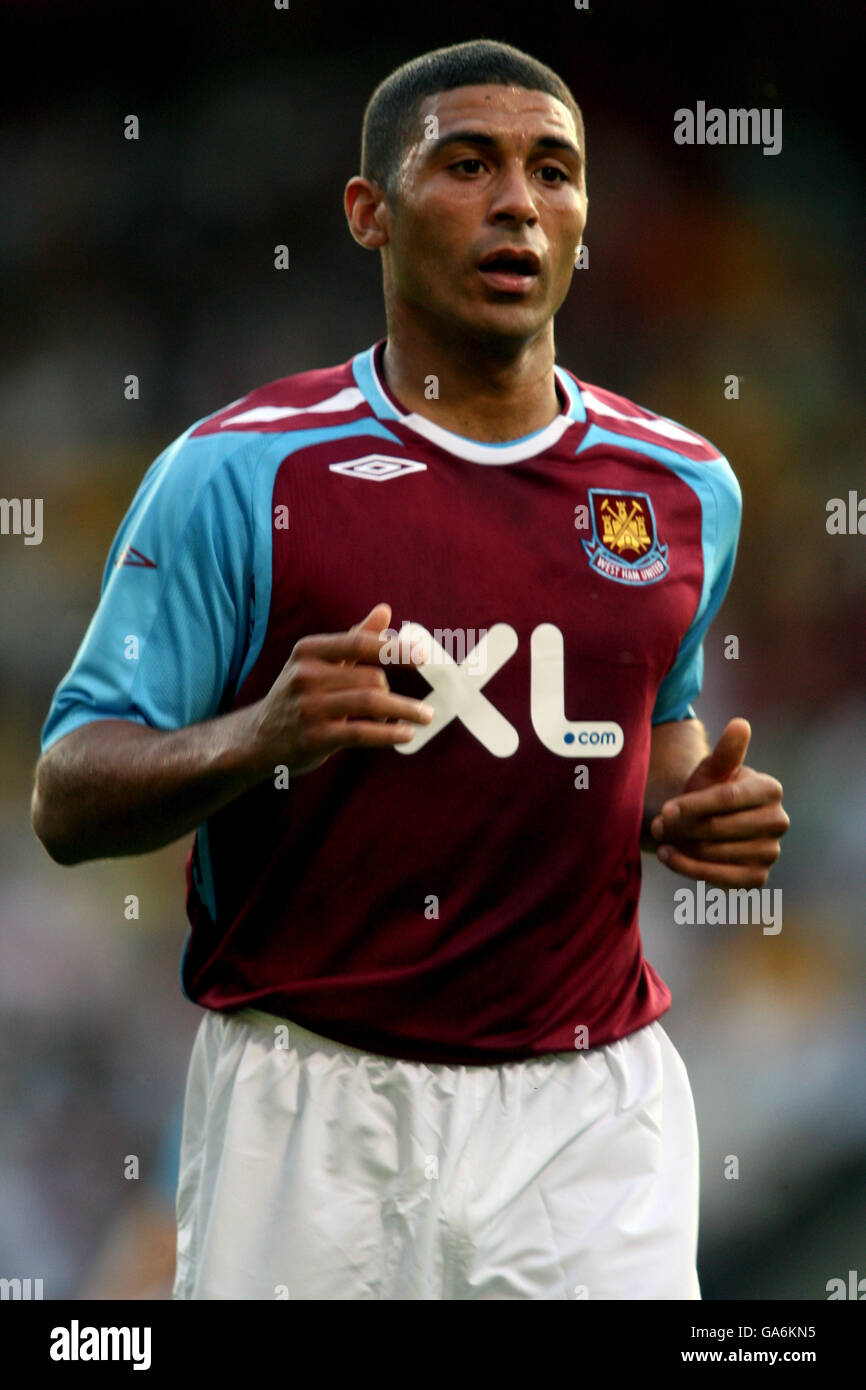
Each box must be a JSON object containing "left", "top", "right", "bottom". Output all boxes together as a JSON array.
[{"left": 652, "top": 457, "right": 742, "bottom": 724}]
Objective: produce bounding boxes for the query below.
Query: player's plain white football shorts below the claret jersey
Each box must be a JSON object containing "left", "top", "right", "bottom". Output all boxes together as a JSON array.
[{"left": 174, "top": 1009, "right": 701, "bottom": 1300}]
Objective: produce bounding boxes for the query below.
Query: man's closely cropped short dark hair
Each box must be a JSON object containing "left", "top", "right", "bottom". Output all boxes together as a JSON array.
[{"left": 361, "top": 39, "right": 587, "bottom": 195}]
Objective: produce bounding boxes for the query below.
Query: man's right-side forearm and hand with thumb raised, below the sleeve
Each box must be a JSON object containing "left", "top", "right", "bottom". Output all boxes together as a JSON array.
[{"left": 641, "top": 719, "right": 791, "bottom": 888}]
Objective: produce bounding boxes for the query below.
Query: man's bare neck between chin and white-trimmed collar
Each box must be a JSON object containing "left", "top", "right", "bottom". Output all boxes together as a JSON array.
[{"left": 382, "top": 327, "right": 562, "bottom": 443}]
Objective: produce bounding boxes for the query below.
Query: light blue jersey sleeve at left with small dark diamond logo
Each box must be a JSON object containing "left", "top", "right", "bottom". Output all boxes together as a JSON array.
[{"left": 42, "top": 427, "right": 261, "bottom": 752}]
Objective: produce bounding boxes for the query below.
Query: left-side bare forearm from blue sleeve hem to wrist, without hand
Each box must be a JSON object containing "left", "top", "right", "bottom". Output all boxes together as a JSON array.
[{"left": 31, "top": 706, "right": 271, "bottom": 865}]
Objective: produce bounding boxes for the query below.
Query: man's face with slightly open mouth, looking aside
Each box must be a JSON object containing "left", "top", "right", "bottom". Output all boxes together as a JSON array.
[{"left": 384, "top": 85, "right": 587, "bottom": 342}]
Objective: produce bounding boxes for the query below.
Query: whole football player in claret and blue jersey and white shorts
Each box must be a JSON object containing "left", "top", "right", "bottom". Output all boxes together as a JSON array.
[{"left": 33, "top": 42, "right": 788, "bottom": 1300}]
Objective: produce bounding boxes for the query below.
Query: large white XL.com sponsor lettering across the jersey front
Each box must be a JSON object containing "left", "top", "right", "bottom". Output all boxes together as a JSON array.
[{"left": 396, "top": 623, "right": 626, "bottom": 758}]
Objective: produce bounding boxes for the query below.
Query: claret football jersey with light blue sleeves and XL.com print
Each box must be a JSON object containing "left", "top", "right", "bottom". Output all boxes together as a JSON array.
[{"left": 42, "top": 341, "right": 741, "bottom": 1063}]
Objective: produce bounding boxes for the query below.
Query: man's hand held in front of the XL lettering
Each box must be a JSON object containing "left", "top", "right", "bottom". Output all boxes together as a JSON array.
[{"left": 250, "top": 603, "right": 434, "bottom": 776}]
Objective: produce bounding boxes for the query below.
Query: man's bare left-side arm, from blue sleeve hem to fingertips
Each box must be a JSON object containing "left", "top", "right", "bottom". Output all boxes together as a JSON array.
[{"left": 31, "top": 605, "right": 434, "bottom": 865}]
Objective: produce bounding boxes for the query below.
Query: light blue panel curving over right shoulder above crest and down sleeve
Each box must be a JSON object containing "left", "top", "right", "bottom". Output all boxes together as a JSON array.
[{"left": 578, "top": 425, "right": 742, "bottom": 724}]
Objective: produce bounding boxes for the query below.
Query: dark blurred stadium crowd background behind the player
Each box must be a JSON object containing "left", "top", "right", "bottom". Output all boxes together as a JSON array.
[{"left": 0, "top": 0, "right": 866, "bottom": 1300}]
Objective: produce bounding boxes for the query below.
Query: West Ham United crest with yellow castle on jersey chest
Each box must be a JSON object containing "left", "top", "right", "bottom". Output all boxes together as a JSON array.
[{"left": 581, "top": 488, "right": 670, "bottom": 585}]
